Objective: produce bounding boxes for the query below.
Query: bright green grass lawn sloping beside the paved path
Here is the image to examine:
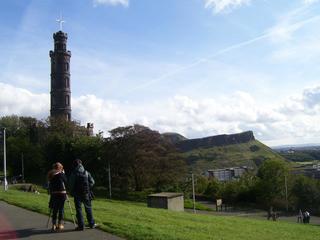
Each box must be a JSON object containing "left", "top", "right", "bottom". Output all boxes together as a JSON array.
[{"left": 0, "top": 189, "right": 320, "bottom": 240}]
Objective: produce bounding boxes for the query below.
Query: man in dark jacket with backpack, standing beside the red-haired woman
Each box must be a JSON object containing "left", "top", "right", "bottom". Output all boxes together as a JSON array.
[{"left": 69, "top": 159, "right": 97, "bottom": 231}]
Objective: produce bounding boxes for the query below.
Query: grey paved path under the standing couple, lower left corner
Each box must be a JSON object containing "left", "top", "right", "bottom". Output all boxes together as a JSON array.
[{"left": 0, "top": 201, "right": 121, "bottom": 240}]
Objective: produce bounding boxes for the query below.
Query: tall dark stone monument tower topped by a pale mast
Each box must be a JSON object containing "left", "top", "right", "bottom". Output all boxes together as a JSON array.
[{"left": 50, "top": 19, "right": 71, "bottom": 121}]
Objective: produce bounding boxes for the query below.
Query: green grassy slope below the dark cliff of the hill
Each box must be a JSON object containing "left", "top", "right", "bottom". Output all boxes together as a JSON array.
[{"left": 182, "top": 140, "right": 285, "bottom": 172}]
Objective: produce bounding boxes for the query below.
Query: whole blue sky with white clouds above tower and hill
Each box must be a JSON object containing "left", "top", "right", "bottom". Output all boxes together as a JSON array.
[{"left": 0, "top": 0, "right": 320, "bottom": 145}]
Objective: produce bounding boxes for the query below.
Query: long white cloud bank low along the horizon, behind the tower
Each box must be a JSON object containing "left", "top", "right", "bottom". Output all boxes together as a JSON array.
[{"left": 0, "top": 83, "right": 320, "bottom": 144}]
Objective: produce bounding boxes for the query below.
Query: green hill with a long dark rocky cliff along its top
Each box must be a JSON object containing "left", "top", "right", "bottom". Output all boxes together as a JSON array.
[{"left": 162, "top": 131, "right": 286, "bottom": 173}]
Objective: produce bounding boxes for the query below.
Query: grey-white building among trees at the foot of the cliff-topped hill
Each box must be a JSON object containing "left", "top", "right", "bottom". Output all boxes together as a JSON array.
[{"left": 208, "top": 166, "right": 249, "bottom": 182}]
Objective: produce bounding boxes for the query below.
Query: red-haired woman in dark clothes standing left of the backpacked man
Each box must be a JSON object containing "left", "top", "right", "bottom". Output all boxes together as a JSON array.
[{"left": 48, "top": 162, "right": 67, "bottom": 231}]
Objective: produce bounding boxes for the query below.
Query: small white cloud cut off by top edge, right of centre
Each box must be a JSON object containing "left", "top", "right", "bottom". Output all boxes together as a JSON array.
[{"left": 204, "top": 0, "right": 251, "bottom": 13}]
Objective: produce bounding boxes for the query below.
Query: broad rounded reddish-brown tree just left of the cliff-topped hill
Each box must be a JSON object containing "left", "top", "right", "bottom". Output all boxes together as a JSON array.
[{"left": 105, "top": 125, "right": 185, "bottom": 191}]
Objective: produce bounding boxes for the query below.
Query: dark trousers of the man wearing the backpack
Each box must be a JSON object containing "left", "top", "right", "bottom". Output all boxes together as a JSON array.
[{"left": 74, "top": 194, "right": 94, "bottom": 228}]
